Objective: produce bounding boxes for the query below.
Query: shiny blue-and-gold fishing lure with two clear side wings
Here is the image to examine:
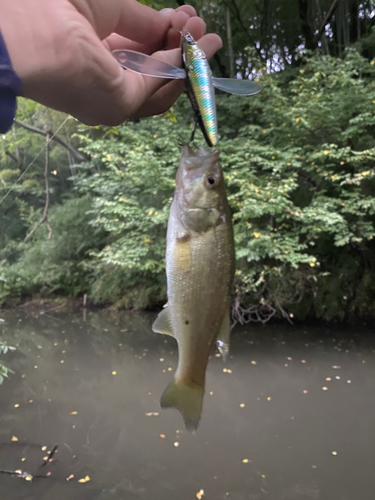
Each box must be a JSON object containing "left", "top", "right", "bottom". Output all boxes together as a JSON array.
[{"left": 112, "top": 30, "right": 261, "bottom": 148}]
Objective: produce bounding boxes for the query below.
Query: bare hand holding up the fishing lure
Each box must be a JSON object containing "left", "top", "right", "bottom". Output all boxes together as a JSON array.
[{"left": 0, "top": 0, "right": 221, "bottom": 125}]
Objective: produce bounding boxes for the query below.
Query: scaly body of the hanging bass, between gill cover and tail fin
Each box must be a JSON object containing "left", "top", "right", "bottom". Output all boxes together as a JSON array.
[{"left": 167, "top": 205, "right": 233, "bottom": 385}]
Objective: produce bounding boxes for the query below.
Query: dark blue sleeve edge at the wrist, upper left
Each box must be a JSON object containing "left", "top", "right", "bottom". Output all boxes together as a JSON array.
[{"left": 0, "top": 31, "right": 21, "bottom": 134}]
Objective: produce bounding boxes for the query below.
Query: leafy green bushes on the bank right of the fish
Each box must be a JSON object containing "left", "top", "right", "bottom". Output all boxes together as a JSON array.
[{"left": 221, "top": 50, "right": 375, "bottom": 319}]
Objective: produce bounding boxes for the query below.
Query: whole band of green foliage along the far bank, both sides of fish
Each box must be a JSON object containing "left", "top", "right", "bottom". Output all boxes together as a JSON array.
[{"left": 0, "top": 49, "right": 375, "bottom": 320}]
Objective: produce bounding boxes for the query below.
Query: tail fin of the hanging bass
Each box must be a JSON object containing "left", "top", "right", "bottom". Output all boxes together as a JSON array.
[{"left": 160, "top": 379, "right": 204, "bottom": 432}]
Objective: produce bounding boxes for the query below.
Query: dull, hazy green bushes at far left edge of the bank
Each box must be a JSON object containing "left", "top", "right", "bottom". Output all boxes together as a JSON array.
[{"left": 0, "top": 197, "right": 107, "bottom": 302}]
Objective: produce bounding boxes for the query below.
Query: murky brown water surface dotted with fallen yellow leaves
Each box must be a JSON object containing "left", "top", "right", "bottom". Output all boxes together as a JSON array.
[{"left": 0, "top": 313, "right": 375, "bottom": 500}]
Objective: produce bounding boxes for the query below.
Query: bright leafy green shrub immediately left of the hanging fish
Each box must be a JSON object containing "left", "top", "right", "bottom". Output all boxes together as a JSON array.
[{"left": 77, "top": 117, "right": 179, "bottom": 307}]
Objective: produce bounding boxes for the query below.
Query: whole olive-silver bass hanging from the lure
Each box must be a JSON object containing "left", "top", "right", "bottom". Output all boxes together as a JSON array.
[{"left": 152, "top": 145, "right": 235, "bottom": 432}]
